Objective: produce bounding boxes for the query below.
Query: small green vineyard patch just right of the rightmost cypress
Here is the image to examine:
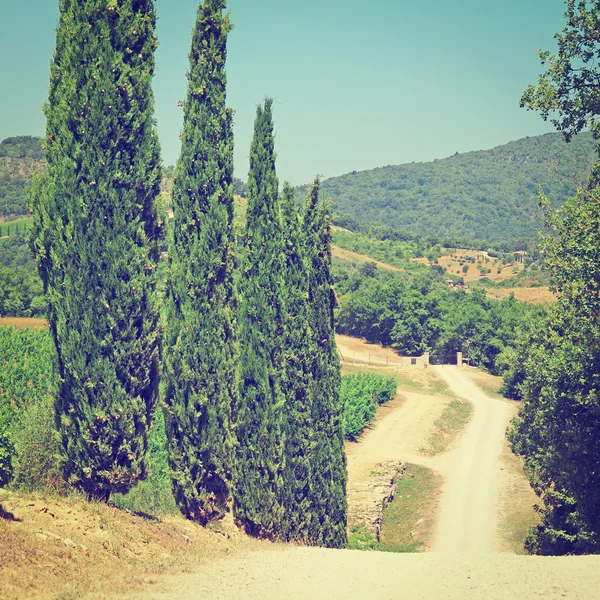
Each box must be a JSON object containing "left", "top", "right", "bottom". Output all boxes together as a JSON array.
[{"left": 340, "top": 373, "right": 396, "bottom": 440}]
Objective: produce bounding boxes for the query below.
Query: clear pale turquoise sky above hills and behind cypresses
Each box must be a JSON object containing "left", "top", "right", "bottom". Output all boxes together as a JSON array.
[{"left": 0, "top": 0, "right": 565, "bottom": 185}]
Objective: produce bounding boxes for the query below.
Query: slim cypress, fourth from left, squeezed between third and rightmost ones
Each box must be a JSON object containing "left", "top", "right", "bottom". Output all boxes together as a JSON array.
[{"left": 281, "top": 183, "right": 314, "bottom": 543}]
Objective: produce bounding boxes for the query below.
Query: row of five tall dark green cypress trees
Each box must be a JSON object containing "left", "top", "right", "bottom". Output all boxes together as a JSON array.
[{"left": 31, "top": 0, "right": 346, "bottom": 547}]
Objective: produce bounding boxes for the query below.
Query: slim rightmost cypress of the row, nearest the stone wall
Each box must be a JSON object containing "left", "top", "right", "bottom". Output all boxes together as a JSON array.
[{"left": 304, "top": 178, "right": 347, "bottom": 548}]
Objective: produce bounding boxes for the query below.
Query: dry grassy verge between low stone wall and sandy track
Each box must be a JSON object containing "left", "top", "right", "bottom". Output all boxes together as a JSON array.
[{"left": 348, "top": 465, "right": 442, "bottom": 552}]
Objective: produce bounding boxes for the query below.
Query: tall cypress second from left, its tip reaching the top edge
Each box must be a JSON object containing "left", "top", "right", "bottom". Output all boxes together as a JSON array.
[{"left": 165, "top": 0, "right": 235, "bottom": 524}]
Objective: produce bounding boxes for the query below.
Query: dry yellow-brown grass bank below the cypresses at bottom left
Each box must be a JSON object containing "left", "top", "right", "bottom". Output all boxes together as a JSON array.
[{"left": 0, "top": 490, "right": 273, "bottom": 600}]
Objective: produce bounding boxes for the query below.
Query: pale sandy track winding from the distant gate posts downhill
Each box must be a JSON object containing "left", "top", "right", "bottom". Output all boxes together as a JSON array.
[{"left": 434, "top": 366, "right": 510, "bottom": 552}]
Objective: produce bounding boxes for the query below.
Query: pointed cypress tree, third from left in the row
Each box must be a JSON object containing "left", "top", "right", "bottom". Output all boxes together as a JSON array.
[{"left": 233, "top": 99, "right": 284, "bottom": 538}]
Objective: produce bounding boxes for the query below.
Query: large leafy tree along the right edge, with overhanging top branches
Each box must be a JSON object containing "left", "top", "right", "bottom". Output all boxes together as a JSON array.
[{"left": 506, "top": 0, "right": 600, "bottom": 554}]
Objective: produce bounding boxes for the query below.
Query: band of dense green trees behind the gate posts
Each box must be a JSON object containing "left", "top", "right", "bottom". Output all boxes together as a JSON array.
[{"left": 337, "top": 269, "right": 545, "bottom": 373}]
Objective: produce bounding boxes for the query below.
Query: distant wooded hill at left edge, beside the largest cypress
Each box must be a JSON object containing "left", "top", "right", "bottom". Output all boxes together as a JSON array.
[{"left": 0, "top": 136, "right": 45, "bottom": 218}]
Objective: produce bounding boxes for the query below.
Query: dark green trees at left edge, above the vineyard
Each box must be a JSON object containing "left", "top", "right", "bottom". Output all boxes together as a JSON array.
[{"left": 0, "top": 234, "right": 46, "bottom": 317}]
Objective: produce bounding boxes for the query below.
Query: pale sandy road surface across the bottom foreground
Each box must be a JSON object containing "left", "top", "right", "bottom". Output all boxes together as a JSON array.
[{"left": 131, "top": 547, "right": 600, "bottom": 600}]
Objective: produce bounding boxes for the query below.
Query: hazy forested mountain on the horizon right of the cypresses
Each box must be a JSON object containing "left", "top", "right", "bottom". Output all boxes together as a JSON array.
[{"left": 314, "top": 132, "right": 595, "bottom": 245}]
